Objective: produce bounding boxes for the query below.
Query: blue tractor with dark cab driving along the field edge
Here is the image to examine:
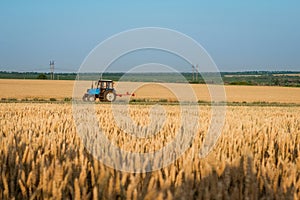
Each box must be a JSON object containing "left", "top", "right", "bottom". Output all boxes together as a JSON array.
[{"left": 82, "top": 79, "right": 117, "bottom": 102}]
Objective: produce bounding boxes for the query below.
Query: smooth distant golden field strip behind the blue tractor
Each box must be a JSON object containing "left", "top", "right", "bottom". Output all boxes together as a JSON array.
[{"left": 0, "top": 79, "right": 300, "bottom": 103}]
